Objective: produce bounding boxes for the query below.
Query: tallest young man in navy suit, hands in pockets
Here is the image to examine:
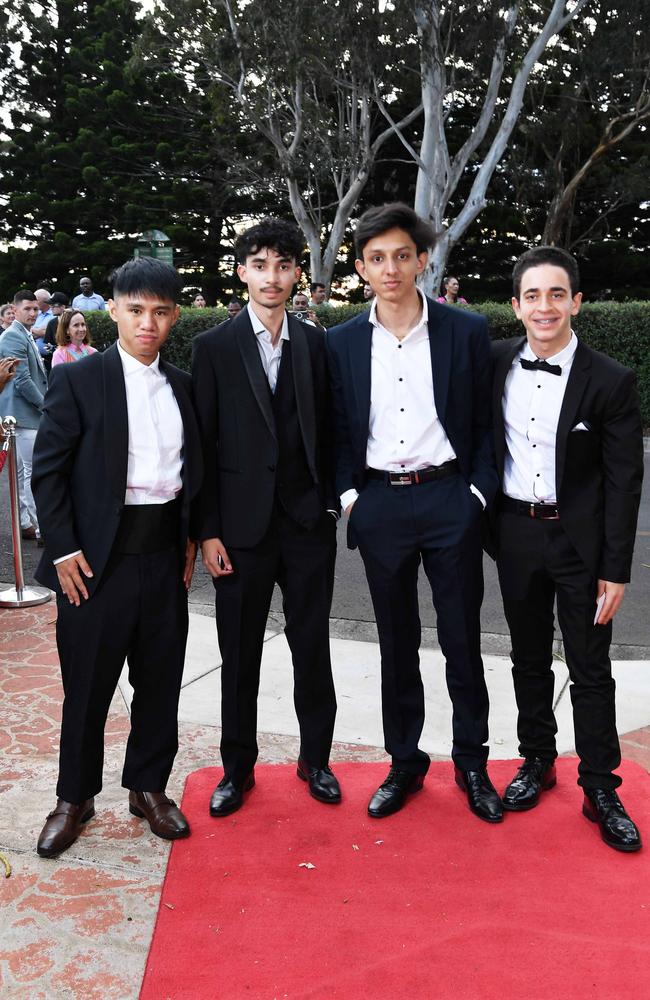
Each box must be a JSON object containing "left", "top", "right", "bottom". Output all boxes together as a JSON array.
[{"left": 328, "top": 204, "right": 503, "bottom": 823}]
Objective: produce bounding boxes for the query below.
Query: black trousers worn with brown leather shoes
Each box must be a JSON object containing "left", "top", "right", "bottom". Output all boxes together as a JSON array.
[{"left": 56, "top": 545, "right": 188, "bottom": 803}]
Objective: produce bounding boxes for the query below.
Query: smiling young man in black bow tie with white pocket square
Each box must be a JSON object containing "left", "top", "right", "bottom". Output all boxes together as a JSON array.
[{"left": 493, "top": 247, "right": 643, "bottom": 851}]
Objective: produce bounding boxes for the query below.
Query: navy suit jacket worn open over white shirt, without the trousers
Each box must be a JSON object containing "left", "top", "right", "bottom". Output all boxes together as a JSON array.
[{"left": 327, "top": 298, "right": 498, "bottom": 505}]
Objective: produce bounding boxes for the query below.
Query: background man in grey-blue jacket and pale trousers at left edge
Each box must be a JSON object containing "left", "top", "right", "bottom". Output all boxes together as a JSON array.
[{"left": 0, "top": 288, "right": 47, "bottom": 544}]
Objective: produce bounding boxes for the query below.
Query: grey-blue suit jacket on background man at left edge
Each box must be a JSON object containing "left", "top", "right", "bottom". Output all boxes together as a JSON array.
[{"left": 0, "top": 320, "right": 47, "bottom": 430}]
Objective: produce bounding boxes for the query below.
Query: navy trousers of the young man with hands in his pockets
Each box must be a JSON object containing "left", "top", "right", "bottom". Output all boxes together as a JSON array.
[{"left": 350, "top": 475, "right": 489, "bottom": 774}]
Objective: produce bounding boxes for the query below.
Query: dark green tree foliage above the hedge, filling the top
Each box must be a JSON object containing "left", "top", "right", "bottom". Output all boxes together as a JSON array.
[{"left": 0, "top": 0, "right": 650, "bottom": 303}]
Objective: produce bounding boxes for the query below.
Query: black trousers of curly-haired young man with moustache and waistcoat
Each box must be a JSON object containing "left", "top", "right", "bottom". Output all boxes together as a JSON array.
[{"left": 214, "top": 504, "right": 336, "bottom": 782}]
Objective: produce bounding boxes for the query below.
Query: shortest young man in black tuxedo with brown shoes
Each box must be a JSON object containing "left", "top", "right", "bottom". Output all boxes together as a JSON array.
[{"left": 32, "top": 258, "right": 201, "bottom": 857}]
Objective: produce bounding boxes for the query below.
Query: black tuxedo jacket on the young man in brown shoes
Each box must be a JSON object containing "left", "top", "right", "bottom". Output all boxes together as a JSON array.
[{"left": 32, "top": 344, "right": 202, "bottom": 594}]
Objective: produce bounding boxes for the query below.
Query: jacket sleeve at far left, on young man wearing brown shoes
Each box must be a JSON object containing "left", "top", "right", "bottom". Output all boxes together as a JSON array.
[{"left": 32, "top": 365, "right": 81, "bottom": 560}]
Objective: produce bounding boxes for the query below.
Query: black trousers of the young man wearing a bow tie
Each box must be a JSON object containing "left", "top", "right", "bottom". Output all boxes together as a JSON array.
[{"left": 497, "top": 511, "right": 621, "bottom": 789}]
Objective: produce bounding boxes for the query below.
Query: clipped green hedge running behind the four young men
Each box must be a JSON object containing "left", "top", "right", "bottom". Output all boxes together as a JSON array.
[{"left": 87, "top": 302, "right": 650, "bottom": 427}]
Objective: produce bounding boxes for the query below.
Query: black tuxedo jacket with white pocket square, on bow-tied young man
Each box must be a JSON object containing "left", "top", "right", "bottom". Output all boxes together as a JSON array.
[{"left": 491, "top": 337, "right": 643, "bottom": 583}]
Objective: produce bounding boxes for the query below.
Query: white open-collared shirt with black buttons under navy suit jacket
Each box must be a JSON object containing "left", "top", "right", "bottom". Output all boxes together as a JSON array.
[{"left": 341, "top": 289, "right": 485, "bottom": 510}]
